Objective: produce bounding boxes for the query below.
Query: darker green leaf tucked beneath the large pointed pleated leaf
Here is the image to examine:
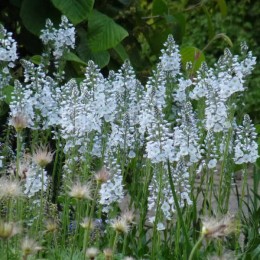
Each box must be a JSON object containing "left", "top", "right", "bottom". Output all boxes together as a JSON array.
[{"left": 77, "top": 29, "right": 110, "bottom": 68}]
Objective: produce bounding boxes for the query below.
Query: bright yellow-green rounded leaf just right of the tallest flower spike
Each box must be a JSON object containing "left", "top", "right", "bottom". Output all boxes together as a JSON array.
[{"left": 180, "top": 47, "right": 205, "bottom": 71}]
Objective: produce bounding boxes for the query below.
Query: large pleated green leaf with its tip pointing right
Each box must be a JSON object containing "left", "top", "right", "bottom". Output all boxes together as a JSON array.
[{"left": 88, "top": 10, "right": 128, "bottom": 52}]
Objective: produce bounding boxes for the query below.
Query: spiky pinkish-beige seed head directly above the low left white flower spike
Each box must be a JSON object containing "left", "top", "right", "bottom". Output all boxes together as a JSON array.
[{"left": 32, "top": 145, "right": 54, "bottom": 168}]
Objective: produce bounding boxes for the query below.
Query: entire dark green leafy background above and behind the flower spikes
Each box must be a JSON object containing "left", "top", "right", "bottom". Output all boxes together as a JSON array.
[{"left": 0, "top": 0, "right": 260, "bottom": 105}]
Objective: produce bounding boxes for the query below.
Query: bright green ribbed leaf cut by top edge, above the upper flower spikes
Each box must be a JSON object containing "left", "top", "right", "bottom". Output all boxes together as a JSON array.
[{"left": 50, "top": 0, "right": 95, "bottom": 25}]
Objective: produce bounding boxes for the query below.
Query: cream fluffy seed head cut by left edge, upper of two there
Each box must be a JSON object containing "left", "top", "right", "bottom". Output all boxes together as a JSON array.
[{"left": 0, "top": 177, "right": 23, "bottom": 199}]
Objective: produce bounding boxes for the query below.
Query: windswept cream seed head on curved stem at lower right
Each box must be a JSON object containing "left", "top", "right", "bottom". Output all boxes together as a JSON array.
[{"left": 202, "top": 215, "right": 237, "bottom": 239}]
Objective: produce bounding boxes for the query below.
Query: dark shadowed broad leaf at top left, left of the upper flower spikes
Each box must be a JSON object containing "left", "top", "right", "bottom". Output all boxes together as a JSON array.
[{"left": 20, "top": 0, "right": 61, "bottom": 35}]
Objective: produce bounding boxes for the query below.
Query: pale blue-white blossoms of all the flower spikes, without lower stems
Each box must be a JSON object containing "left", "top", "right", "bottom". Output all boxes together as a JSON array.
[{"left": 3, "top": 17, "right": 258, "bottom": 221}]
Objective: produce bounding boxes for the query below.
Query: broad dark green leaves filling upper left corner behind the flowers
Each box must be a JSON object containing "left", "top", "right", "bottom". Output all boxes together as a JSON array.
[{"left": 0, "top": 0, "right": 129, "bottom": 71}]
